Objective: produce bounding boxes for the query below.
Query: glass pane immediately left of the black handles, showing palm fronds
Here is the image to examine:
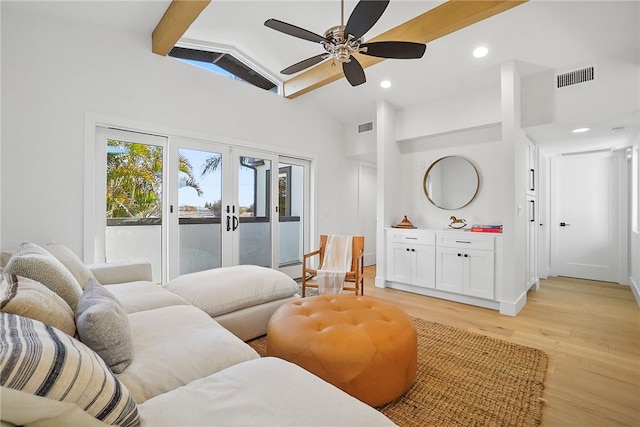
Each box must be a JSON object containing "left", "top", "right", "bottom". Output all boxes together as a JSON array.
[{"left": 177, "top": 148, "right": 222, "bottom": 274}]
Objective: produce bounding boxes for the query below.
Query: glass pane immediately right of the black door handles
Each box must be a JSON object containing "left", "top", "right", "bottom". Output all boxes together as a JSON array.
[{"left": 236, "top": 153, "right": 275, "bottom": 267}]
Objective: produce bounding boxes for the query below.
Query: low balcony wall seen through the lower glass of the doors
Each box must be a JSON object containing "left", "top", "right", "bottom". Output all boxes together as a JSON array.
[{"left": 106, "top": 216, "right": 303, "bottom": 282}]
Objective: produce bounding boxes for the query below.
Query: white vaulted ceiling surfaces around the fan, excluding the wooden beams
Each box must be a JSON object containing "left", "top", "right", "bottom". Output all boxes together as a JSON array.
[{"left": 13, "top": 0, "right": 640, "bottom": 154}]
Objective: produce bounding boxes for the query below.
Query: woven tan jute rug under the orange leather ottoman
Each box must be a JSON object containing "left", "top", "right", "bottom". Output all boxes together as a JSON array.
[{"left": 248, "top": 318, "right": 548, "bottom": 427}]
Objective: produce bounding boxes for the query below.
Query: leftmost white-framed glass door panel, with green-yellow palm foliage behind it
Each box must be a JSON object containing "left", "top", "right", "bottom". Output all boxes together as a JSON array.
[{"left": 91, "top": 127, "right": 168, "bottom": 282}]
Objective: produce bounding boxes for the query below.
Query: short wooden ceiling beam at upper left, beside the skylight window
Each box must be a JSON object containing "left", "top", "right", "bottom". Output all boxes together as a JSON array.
[{"left": 151, "top": 0, "right": 211, "bottom": 56}]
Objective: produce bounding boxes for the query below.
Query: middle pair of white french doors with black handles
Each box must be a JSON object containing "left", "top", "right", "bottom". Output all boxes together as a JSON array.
[{"left": 168, "top": 142, "right": 277, "bottom": 280}]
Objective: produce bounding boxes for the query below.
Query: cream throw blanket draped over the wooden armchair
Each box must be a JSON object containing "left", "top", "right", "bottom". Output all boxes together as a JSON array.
[{"left": 318, "top": 235, "right": 353, "bottom": 295}]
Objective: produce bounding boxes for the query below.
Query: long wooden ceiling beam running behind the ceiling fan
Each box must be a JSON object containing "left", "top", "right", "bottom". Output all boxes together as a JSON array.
[{"left": 283, "top": 0, "right": 528, "bottom": 99}]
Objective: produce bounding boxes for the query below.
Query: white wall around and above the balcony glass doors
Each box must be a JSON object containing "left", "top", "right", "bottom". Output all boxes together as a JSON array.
[{"left": 1, "top": 2, "right": 358, "bottom": 254}]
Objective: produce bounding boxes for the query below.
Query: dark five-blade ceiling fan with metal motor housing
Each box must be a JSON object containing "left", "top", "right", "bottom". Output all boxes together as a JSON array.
[{"left": 264, "top": 0, "right": 427, "bottom": 86}]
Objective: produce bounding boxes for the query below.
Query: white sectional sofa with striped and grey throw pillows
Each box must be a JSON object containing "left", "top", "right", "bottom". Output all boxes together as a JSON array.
[{"left": 0, "top": 243, "right": 393, "bottom": 426}]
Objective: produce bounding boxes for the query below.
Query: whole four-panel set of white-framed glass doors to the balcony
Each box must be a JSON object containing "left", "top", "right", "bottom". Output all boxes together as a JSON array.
[{"left": 94, "top": 128, "right": 309, "bottom": 282}]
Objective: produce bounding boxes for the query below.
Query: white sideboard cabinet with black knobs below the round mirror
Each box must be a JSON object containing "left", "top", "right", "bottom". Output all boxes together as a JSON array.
[{"left": 385, "top": 228, "right": 502, "bottom": 310}]
